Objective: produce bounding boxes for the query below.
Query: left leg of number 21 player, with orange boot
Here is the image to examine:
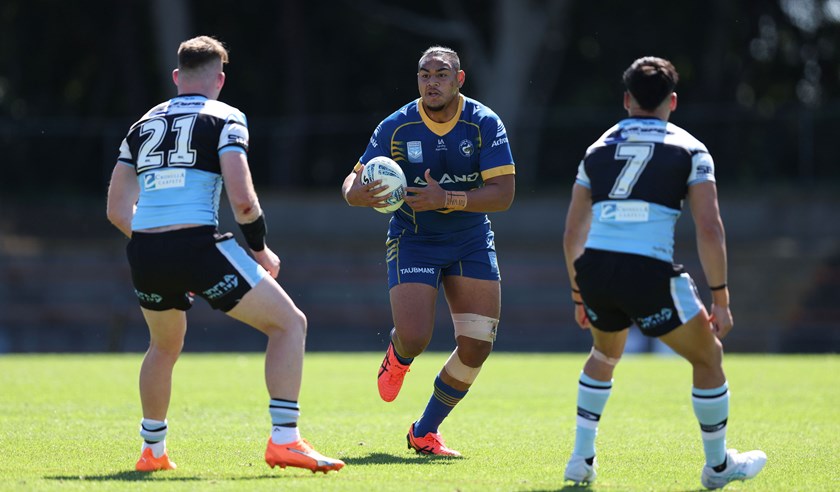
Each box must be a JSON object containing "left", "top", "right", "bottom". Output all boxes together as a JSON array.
[{"left": 135, "top": 308, "right": 187, "bottom": 471}]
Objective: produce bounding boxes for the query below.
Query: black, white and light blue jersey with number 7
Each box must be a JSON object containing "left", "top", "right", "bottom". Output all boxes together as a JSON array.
[{"left": 575, "top": 118, "right": 715, "bottom": 262}]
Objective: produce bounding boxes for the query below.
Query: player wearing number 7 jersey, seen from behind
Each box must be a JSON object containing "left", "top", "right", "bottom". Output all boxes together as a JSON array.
[{"left": 563, "top": 57, "right": 767, "bottom": 489}]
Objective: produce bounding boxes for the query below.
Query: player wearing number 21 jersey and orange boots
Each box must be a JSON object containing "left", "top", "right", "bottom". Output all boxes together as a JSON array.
[{"left": 108, "top": 36, "right": 344, "bottom": 473}]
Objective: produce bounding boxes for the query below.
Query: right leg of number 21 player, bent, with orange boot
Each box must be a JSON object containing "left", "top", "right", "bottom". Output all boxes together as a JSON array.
[{"left": 227, "top": 275, "right": 344, "bottom": 473}]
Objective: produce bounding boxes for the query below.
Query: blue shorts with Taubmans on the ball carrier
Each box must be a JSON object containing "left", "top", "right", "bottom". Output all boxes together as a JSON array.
[{"left": 385, "top": 222, "right": 501, "bottom": 289}]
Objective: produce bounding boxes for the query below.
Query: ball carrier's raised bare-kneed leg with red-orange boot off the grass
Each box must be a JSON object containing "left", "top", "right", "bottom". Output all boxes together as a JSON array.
[{"left": 376, "top": 282, "right": 437, "bottom": 402}]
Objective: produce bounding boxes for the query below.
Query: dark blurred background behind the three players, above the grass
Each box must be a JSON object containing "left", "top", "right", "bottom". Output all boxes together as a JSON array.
[{"left": 0, "top": 0, "right": 840, "bottom": 352}]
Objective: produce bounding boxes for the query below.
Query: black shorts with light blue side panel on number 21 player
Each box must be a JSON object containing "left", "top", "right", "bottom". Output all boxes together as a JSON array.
[{"left": 126, "top": 226, "right": 267, "bottom": 311}]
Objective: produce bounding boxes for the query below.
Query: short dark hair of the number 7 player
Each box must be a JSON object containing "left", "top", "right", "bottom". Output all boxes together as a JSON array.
[{"left": 622, "top": 56, "right": 680, "bottom": 110}]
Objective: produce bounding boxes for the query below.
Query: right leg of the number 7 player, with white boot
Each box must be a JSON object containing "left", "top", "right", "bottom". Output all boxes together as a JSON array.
[{"left": 660, "top": 309, "right": 767, "bottom": 488}]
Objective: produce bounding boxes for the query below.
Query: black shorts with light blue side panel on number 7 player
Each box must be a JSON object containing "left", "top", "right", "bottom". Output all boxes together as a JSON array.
[{"left": 575, "top": 248, "right": 704, "bottom": 337}]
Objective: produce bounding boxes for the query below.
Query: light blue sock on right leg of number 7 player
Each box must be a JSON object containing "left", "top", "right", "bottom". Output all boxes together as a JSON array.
[{"left": 691, "top": 382, "right": 729, "bottom": 467}]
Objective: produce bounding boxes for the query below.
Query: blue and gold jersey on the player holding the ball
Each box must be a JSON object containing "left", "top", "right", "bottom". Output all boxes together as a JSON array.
[{"left": 359, "top": 95, "right": 514, "bottom": 234}]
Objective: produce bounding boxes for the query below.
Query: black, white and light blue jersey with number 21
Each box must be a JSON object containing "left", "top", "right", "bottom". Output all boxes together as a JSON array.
[{"left": 118, "top": 94, "right": 248, "bottom": 231}]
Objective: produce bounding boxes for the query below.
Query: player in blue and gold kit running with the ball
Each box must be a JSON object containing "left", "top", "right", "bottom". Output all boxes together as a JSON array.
[{"left": 342, "top": 46, "right": 515, "bottom": 456}]
